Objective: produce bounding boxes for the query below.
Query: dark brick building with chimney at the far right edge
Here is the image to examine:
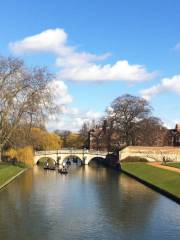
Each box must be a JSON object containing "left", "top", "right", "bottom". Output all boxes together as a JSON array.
[{"left": 168, "top": 124, "right": 180, "bottom": 147}]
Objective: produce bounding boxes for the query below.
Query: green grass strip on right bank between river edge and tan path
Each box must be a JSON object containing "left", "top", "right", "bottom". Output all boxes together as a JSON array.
[{"left": 121, "top": 163, "right": 180, "bottom": 198}]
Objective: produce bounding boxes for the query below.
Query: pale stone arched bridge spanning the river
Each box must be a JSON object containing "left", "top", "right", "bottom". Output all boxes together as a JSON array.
[{"left": 34, "top": 149, "right": 107, "bottom": 164}]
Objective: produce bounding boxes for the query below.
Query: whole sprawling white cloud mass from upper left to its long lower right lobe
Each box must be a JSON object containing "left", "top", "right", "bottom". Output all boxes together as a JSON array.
[{"left": 10, "top": 28, "right": 157, "bottom": 82}]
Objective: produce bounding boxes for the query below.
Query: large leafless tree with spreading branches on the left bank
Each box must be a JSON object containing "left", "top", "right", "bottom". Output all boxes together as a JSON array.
[{"left": 0, "top": 57, "right": 53, "bottom": 161}]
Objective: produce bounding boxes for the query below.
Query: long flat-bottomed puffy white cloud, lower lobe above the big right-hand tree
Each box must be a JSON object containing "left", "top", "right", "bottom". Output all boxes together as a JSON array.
[{"left": 59, "top": 60, "right": 156, "bottom": 82}]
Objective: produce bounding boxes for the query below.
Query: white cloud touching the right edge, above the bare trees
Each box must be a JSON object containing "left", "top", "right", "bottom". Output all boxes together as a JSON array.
[{"left": 141, "top": 75, "right": 180, "bottom": 100}]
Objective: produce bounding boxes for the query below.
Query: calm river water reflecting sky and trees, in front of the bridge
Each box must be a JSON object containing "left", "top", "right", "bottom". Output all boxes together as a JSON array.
[{"left": 0, "top": 166, "right": 180, "bottom": 240}]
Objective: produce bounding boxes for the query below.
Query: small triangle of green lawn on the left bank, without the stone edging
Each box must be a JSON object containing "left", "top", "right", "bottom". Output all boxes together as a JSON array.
[{"left": 0, "top": 163, "right": 23, "bottom": 186}]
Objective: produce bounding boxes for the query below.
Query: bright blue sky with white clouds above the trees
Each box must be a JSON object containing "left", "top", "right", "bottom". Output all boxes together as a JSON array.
[{"left": 0, "top": 0, "right": 180, "bottom": 130}]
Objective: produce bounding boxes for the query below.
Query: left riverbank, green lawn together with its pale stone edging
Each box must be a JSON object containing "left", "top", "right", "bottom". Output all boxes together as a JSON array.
[{"left": 0, "top": 163, "right": 27, "bottom": 189}]
